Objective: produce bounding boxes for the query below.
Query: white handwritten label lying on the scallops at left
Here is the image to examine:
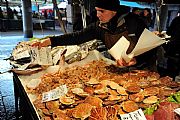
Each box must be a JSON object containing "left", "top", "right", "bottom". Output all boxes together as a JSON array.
[{"left": 42, "top": 85, "right": 68, "bottom": 102}]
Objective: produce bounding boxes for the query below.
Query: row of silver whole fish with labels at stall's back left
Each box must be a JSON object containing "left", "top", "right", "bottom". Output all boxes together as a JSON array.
[{"left": 9, "top": 40, "right": 98, "bottom": 74}]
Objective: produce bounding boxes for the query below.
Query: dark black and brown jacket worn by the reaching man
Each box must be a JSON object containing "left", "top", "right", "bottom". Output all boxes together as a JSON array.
[{"left": 50, "top": 12, "right": 156, "bottom": 70}]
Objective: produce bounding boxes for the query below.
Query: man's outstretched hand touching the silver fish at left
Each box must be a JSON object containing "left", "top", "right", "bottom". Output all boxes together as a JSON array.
[{"left": 31, "top": 38, "right": 51, "bottom": 48}]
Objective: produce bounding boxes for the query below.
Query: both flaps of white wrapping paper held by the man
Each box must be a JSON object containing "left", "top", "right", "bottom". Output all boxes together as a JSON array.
[{"left": 108, "top": 29, "right": 166, "bottom": 62}]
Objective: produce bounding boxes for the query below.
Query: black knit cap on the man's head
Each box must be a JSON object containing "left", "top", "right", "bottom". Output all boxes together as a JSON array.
[{"left": 95, "top": 0, "right": 120, "bottom": 11}]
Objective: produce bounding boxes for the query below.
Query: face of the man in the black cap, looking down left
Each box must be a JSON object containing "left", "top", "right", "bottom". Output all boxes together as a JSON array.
[{"left": 95, "top": 7, "right": 117, "bottom": 23}]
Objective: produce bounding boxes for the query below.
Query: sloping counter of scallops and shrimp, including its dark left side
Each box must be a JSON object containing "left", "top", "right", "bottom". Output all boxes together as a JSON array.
[{"left": 11, "top": 50, "right": 180, "bottom": 120}]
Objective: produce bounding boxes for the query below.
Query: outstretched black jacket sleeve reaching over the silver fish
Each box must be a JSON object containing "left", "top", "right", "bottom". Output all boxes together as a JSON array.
[{"left": 50, "top": 23, "right": 98, "bottom": 47}]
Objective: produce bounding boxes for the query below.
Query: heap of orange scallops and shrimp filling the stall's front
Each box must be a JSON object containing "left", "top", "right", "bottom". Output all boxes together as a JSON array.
[{"left": 26, "top": 60, "right": 180, "bottom": 120}]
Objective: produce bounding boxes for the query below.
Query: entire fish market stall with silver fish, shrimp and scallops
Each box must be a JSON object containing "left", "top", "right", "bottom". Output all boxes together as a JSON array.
[{"left": 11, "top": 37, "right": 180, "bottom": 120}]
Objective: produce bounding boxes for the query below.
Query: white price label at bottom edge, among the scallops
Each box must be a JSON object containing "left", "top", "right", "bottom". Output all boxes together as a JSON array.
[{"left": 120, "top": 109, "right": 146, "bottom": 120}]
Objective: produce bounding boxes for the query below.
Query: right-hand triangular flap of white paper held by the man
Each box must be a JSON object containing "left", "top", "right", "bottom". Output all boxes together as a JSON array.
[{"left": 131, "top": 29, "right": 166, "bottom": 56}]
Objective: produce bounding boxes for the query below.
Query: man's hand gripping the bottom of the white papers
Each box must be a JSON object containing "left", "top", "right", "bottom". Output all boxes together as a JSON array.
[{"left": 116, "top": 58, "right": 136, "bottom": 66}]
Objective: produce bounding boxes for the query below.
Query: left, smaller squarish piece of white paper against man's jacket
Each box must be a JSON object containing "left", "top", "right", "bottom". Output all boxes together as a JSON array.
[{"left": 108, "top": 36, "right": 133, "bottom": 62}]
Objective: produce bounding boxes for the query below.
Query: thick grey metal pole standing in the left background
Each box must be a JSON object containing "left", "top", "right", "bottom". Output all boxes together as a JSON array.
[{"left": 21, "top": 0, "right": 33, "bottom": 38}]
